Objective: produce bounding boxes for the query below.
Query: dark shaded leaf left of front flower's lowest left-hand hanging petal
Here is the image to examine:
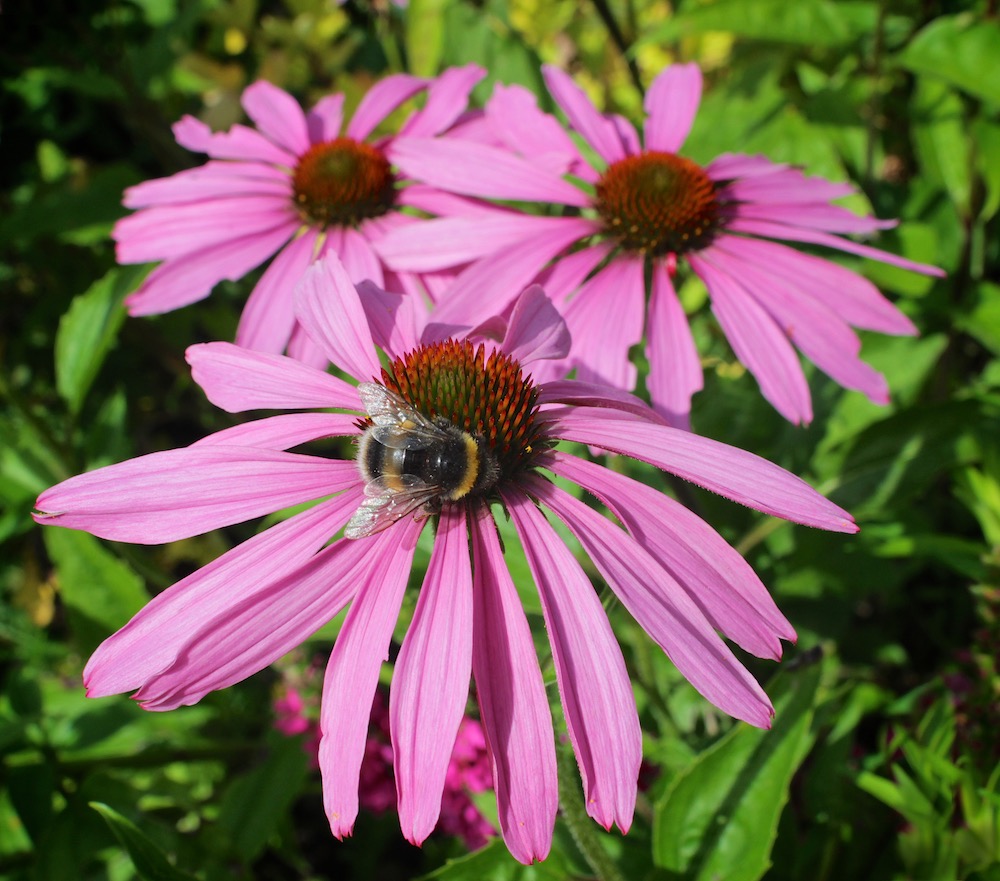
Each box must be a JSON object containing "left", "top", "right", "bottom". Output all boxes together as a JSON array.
[{"left": 219, "top": 737, "right": 309, "bottom": 864}]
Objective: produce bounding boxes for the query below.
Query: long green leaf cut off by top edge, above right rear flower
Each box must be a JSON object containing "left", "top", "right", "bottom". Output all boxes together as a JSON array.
[{"left": 637, "top": 0, "right": 853, "bottom": 48}]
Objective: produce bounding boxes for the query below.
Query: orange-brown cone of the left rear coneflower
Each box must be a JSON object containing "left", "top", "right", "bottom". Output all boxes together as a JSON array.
[{"left": 292, "top": 138, "right": 395, "bottom": 227}]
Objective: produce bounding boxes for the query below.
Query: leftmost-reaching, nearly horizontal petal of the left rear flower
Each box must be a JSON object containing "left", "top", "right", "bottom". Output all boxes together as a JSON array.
[{"left": 115, "top": 196, "right": 299, "bottom": 263}]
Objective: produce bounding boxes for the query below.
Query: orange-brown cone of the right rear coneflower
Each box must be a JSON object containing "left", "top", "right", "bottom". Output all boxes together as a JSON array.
[{"left": 595, "top": 151, "right": 719, "bottom": 257}]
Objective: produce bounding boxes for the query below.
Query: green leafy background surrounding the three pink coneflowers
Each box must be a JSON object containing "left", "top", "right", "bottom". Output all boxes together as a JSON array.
[{"left": 0, "top": 0, "right": 1000, "bottom": 881}]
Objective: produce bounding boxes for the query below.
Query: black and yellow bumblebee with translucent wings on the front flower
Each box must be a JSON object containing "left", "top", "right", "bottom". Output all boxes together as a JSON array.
[{"left": 344, "top": 382, "right": 500, "bottom": 538}]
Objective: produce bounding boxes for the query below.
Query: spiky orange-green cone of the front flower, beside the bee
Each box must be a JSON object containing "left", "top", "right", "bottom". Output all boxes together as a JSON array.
[{"left": 382, "top": 340, "right": 546, "bottom": 481}]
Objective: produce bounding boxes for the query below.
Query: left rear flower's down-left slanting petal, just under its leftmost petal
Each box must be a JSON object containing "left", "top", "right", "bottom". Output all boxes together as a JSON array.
[{"left": 125, "top": 226, "right": 295, "bottom": 315}]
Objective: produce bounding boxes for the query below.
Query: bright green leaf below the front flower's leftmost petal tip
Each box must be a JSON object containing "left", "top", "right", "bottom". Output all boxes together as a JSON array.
[{"left": 43, "top": 528, "right": 149, "bottom": 649}]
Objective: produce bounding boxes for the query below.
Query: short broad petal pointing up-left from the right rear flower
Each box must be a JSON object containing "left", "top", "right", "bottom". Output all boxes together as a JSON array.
[{"left": 486, "top": 83, "right": 583, "bottom": 176}]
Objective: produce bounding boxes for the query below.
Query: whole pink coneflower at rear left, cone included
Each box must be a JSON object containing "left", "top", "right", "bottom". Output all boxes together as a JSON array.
[{"left": 114, "top": 65, "right": 484, "bottom": 363}]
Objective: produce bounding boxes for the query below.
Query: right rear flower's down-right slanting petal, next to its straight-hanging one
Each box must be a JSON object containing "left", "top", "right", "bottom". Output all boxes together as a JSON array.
[{"left": 687, "top": 254, "right": 812, "bottom": 425}]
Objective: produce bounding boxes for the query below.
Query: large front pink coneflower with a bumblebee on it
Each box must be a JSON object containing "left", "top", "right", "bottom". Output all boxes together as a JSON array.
[{"left": 36, "top": 258, "right": 856, "bottom": 862}]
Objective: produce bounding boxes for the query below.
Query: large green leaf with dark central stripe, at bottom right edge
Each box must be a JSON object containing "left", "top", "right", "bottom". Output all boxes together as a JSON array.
[{"left": 653, "top": 666, "right": 820, "bottom": 881}]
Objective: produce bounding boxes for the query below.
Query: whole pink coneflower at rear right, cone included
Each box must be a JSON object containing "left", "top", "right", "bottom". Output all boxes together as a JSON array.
[{"left": 377, "top": 64, "right": 941, "bottom": 426}]
